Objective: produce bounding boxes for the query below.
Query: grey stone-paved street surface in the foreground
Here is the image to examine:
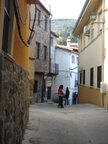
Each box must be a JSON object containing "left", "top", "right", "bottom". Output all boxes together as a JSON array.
[{"left": 23, "top": 103, "right": 108, "bottom": 144}]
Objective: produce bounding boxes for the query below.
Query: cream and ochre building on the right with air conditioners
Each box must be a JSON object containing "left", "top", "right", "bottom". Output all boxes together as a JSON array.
[{"left": 73, "top": 0, "right": 108, "bottom": 108}]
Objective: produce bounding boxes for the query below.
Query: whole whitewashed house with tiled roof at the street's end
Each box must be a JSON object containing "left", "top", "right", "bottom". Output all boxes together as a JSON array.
[{"left": 52, "top": 40, "right": 78, "bottom": 104}]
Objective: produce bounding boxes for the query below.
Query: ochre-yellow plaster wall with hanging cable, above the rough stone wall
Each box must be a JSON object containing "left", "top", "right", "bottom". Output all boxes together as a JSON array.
[{"left": 13, "top": 0, "right": 29, "bottom": 70}]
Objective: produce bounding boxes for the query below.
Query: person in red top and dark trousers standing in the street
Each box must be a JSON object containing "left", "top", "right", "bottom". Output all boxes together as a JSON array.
[{"left": 58, "top": 85, "right": 63, "bottom": 108}]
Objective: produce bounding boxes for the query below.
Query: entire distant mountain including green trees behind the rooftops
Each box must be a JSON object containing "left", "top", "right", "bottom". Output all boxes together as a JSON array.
[{"left": 51, "top": 19, "right": 78, "bottom": 45}]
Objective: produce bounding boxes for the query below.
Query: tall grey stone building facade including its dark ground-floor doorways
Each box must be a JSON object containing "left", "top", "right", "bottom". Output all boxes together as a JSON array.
[{"left": 30, "top": 0, "right": 51, "bottom": 102}]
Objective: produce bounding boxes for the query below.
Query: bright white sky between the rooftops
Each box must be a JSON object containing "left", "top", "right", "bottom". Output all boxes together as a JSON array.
[{"left": 41, "top": 0, "right": 85, "bottom": 19}]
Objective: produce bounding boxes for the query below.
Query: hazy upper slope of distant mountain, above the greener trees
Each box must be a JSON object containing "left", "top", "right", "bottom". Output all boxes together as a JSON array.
[{"left": 51, "top": 19, "right": 76, "bottom": 33}]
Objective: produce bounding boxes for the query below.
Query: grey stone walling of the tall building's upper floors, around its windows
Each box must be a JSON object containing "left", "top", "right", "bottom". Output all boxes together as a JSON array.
[{"left": 34, "top": 4, "right": 51, "bottom": 73}]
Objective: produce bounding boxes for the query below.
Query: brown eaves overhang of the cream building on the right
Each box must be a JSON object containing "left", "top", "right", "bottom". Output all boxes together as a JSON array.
[{"left": 73, "top": 0, "right": 102, "bottom": 36}]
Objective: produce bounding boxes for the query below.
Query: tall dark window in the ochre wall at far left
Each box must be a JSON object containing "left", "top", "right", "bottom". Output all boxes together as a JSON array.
[{"left": 2, "top": 0, "right": 11, "bottom": 53}]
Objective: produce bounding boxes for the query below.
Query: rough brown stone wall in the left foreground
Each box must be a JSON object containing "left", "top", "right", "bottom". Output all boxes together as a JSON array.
[{"left": 0, "top": 52, "right": 29, "bottom": 144}]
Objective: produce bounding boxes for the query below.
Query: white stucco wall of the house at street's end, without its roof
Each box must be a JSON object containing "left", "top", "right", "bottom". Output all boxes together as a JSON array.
[{"left": 52, "top": 48, "right": 78, "bottom": 103}]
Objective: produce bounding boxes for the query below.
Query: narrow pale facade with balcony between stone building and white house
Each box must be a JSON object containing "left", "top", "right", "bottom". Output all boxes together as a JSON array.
[{"left": 46, "top": 31, "right": 59, "bottom": 100}]
